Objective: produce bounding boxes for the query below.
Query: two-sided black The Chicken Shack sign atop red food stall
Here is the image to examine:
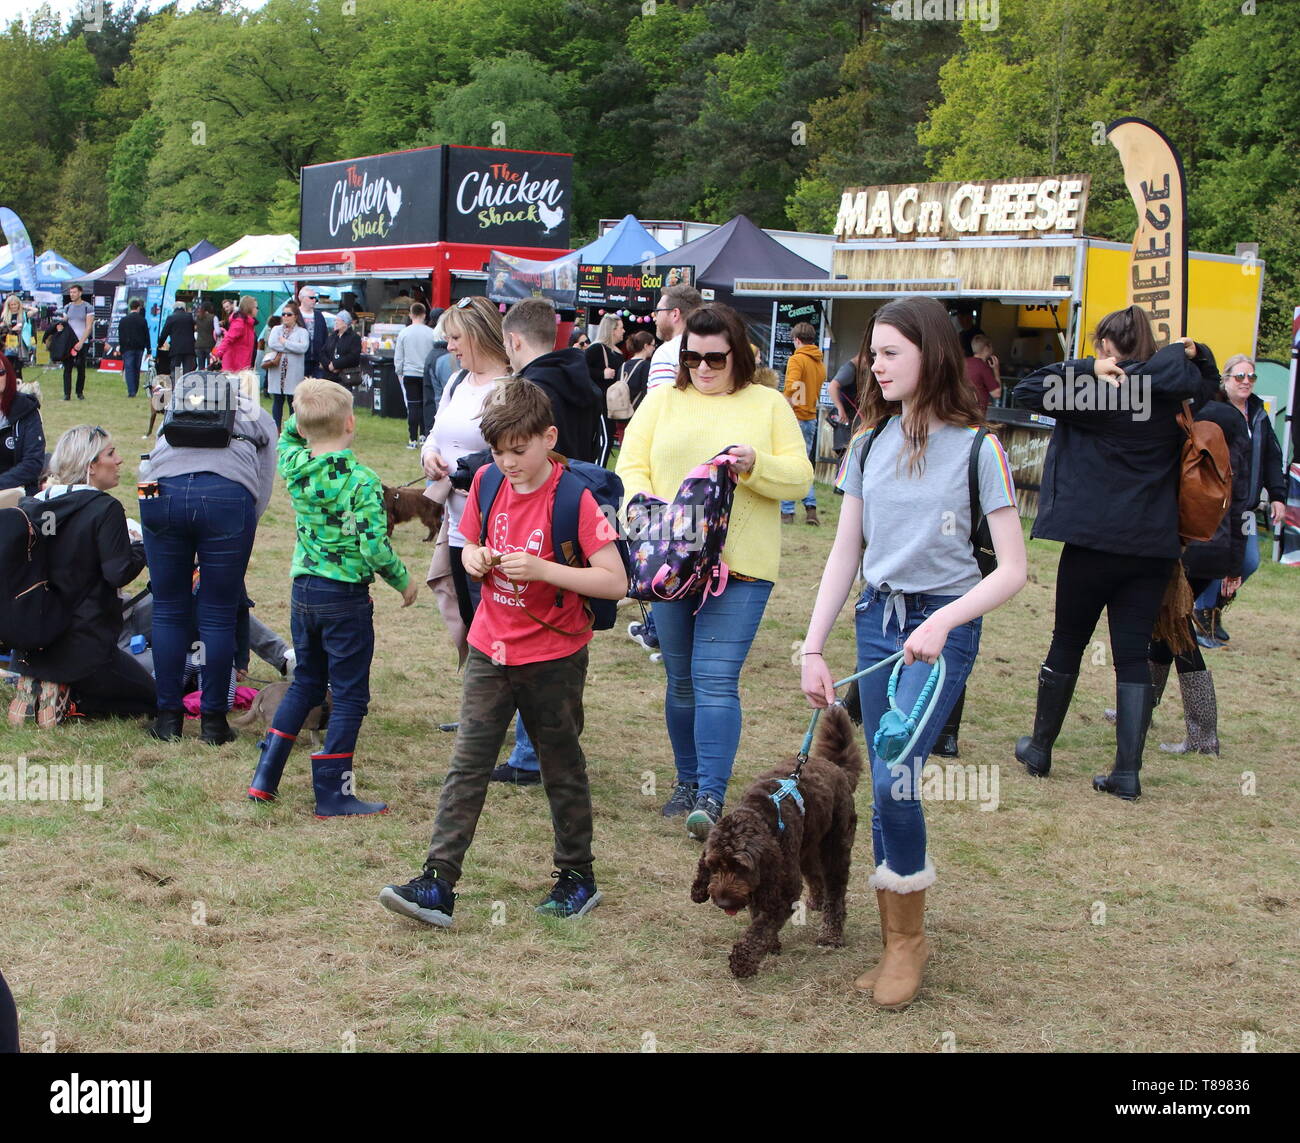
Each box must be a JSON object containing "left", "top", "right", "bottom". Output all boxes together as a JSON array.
[{"left": 299, "top": 146, "right": 573, "bottom": 250}]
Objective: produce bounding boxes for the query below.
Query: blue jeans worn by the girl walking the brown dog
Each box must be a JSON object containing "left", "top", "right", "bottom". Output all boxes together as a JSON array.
[{"left": 854, "top": 588, "right": 983, "bottom": 876}]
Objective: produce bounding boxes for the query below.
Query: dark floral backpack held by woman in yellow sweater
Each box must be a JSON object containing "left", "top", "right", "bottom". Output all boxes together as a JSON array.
[{"left": 627, "top": 446, "right": 736, "bottom": 611}]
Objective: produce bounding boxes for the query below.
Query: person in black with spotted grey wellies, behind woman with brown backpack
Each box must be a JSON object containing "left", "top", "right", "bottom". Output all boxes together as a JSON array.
[{"left": 1151, "top": 390, "right": 1253, "bottom": 754}]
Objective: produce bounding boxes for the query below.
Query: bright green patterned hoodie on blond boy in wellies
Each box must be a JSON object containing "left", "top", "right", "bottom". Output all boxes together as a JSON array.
[{"left": 280, "top": 416, "right": 410, "bottom": 592}]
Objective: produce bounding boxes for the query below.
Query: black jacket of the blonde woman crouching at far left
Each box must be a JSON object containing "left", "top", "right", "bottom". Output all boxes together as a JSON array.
[{"left": 16, "top": 489, "right": 144, "bottom": 683}]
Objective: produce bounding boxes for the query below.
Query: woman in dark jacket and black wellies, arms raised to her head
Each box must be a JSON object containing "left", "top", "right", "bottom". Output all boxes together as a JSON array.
[{"left": 1014, "top": 306, "right": 1218, "bottom": 800}]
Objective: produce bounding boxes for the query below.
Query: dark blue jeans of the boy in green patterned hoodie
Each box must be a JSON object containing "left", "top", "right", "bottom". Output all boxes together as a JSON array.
[{"left": 272, "top": 575, "right": 374, "bottom": 754}]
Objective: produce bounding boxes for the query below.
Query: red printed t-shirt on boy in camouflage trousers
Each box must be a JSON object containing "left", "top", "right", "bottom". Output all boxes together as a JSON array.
[{"left": 460, "top": 460, "right": 618, "bottom": 667}]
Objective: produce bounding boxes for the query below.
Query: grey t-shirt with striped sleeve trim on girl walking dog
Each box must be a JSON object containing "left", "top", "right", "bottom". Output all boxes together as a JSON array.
[{"left": 840, "top": 417, "right": 1015, "bottom": 596}]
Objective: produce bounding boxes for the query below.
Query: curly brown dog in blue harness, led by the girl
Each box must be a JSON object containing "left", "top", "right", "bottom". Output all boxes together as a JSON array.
[{"left": 690, "top": 703, "right": 862, "bottom": 977}]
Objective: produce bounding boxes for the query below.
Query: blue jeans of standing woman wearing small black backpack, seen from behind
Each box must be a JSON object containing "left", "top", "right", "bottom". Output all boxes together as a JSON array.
[{"left": 138, "top": 472, "right": 257, "bottom": 714}]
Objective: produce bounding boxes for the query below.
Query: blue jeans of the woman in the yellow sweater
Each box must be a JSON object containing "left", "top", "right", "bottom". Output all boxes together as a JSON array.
[{"left": 654, "top": 579, "right": 772, "bottom": 801}]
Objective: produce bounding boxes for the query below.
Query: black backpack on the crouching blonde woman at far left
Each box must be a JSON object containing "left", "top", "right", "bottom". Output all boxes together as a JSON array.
[{"left": 0, "top": 498, "right": 75, "bottom": 651}]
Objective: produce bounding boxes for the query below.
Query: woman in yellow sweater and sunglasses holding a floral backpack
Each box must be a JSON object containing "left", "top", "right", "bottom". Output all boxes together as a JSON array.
[{"left": 618, "top": 306, "right": 813, "bottom": 841}]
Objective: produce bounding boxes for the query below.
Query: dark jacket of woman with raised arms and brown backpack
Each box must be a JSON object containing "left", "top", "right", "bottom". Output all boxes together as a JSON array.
[{"left": 1013, "top": 342, "right": 1218, "bottom": 559}]
